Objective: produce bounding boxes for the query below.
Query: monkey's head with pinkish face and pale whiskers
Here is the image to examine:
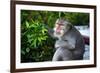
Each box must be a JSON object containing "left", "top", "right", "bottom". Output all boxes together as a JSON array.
[{"left": 54, "top": 18, "right": 71, "bottom": 38}]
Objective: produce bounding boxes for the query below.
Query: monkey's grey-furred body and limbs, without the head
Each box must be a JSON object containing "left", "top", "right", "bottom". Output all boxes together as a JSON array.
[{"left": 49, "top": 18, "right": 85, "bottom": 61}]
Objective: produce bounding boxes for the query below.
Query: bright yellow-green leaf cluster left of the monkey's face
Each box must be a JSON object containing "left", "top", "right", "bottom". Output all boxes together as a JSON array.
[{"left": 26, "top": 21, "right": 48, "bottom": 48}]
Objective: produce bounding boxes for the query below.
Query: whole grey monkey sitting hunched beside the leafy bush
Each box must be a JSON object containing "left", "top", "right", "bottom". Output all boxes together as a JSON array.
[{"left": 48, "top": 18, "right": 85, "bottom": 61}]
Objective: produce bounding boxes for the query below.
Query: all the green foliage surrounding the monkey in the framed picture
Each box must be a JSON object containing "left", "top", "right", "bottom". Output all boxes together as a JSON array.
[{"left": 21, "top": 10, "right": 89, "bottom": 63}]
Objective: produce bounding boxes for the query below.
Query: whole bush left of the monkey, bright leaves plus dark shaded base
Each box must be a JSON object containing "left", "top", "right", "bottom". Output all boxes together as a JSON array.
[{"left": 21, "top": 20, "right": 53, "bottom": 62}]
